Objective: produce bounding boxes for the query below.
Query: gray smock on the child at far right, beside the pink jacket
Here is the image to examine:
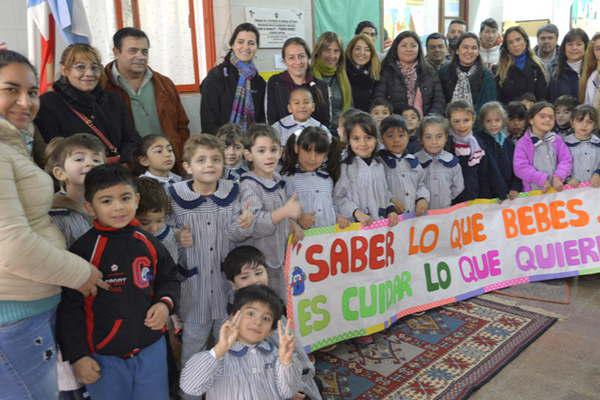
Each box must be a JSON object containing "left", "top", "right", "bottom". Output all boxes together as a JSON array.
[{"left": 565, "top": 134, "right": 600, "bottom": 182}]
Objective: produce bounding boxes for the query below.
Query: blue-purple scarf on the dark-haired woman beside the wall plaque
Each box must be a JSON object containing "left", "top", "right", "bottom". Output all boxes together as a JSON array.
[{"left": 229, "top": 52, "right": 258, "bottom": 130}]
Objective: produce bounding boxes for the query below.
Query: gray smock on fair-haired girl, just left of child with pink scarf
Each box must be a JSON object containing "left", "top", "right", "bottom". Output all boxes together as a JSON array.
[{"left": 415, "top": 150, "right": 465, "bottom": 210}]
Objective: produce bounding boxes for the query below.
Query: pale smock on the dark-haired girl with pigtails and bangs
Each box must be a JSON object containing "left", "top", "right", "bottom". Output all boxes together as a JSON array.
[{"left": 283, "top": 168, "right": 336, "bottom": 228}]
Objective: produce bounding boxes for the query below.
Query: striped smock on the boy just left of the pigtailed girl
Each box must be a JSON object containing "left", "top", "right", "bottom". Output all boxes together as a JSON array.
[{"left": 240, "top": 171, "right": 289, "bottom": 268}]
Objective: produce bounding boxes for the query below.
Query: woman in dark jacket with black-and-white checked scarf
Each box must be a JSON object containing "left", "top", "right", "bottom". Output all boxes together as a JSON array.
[{"left": 439, "top": 32, "right": 496, "bottom": 112}]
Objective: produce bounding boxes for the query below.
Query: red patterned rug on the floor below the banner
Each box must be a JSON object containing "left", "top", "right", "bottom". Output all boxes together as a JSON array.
[{"left": 315, "top": 299, "right": 556, "bottom": 400}]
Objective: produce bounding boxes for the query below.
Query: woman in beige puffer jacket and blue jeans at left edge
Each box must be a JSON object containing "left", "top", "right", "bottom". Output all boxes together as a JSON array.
[{"left": 0, "top": 50, "right": 106, "bottom": 399}]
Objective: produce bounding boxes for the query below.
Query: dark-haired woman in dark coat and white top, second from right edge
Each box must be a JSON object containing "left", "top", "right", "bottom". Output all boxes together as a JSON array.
[{"left": 548, "top": 28, "right": 590, "bottom": 103}]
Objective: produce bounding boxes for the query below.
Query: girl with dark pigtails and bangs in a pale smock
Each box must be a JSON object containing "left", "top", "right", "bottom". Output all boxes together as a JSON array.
[{"left": 281, "top": 127, "right": 350, "bottom": 229}]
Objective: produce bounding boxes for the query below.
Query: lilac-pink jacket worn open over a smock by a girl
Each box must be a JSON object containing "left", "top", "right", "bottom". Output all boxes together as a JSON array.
[{"left": 513, "top": 129, "right": 573, "bottom": 192}]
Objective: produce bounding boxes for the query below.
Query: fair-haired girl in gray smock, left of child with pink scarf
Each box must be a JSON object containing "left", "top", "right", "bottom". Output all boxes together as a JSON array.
[{"left": 415, "top": 115, "right": 465, "bottom": 210}]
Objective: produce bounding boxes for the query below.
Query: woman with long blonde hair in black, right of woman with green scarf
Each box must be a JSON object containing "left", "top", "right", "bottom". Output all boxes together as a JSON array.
[{"left": 346, "top": 34, "right": 381, "bottom": 112}]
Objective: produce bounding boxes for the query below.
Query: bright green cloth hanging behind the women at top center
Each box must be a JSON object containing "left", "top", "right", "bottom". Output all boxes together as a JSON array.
[{"left": 313, "top": 0, "right": 383, "bottom": 51}]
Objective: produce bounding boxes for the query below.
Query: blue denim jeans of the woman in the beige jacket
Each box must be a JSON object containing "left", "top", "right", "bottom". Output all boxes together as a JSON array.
[{"left": 0, "top": 308, "right": 58, "bottom": 400}]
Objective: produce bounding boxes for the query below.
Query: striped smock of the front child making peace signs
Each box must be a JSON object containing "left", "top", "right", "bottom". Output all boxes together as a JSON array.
[{"left": 180, "top": 340, "right": 302, "bottom": 400}]
